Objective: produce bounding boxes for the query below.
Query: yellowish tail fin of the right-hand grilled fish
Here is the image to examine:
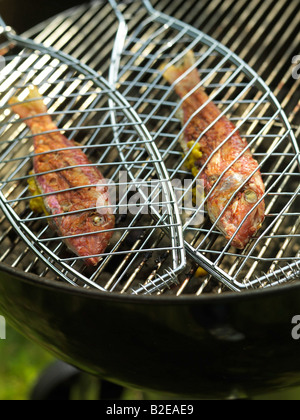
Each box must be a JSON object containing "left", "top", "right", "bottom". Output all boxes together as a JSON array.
[{"left": 160, "top": 51, "right": 200, "bottom": 97}]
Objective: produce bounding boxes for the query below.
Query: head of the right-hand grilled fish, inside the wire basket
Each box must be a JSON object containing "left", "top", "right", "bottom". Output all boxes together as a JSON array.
[{"left": 208, "top": 173, "right": 265, "bottom": 249}]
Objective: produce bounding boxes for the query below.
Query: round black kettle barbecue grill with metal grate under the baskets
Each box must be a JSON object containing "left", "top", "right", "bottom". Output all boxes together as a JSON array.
[{"left": 0, "top": 0, "right": 300, "bottom": 398}]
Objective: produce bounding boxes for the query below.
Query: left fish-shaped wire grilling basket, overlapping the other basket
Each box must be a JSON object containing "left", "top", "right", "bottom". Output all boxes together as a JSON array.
[{"left": 0, "top": 21, "right": 185, "bottom": 293}]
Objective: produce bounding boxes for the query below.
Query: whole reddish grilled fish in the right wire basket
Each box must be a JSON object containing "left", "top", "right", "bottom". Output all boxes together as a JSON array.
[{"left": 161, "top": 51, "right": 265, "bottom": 249}]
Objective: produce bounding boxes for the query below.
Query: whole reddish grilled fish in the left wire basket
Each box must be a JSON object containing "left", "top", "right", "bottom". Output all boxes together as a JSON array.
[{"left": 10, "top": 87, "right": 115, "bottom": 266}]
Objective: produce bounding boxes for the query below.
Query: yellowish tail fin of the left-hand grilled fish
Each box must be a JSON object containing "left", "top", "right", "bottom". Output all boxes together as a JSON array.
[{"left": 9, "top": 86, "right": 49, "bottom": 126}]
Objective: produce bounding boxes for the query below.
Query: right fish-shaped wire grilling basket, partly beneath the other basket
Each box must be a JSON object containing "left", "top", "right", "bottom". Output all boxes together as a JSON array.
[{"left": 106, "top": 0, "right": 300, "bottom": 291}]
